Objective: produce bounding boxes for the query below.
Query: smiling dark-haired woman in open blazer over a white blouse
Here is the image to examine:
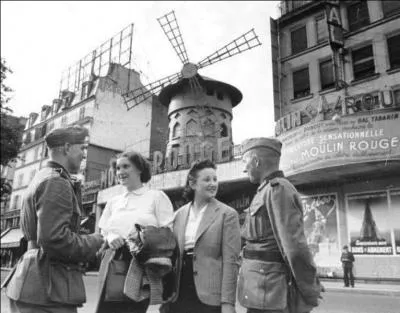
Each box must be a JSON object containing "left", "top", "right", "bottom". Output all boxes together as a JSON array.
[{"left": 168, "top": 160, "right": 240, "bottom": 313}]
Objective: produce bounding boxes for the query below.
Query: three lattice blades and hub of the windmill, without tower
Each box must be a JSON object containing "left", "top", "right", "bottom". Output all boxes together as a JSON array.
[{"left": 122, "top": 11, "right": 261, "bottom": 110}]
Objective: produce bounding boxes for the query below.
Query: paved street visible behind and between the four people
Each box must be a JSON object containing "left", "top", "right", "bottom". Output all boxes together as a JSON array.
[{"left": 1, "top": 276, "right": 400, "bottom": 313}]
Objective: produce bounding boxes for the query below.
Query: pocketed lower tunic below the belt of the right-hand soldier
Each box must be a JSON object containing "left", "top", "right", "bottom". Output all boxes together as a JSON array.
[{"left": 238, "top": 259, "right": 288, "bottom": 310}]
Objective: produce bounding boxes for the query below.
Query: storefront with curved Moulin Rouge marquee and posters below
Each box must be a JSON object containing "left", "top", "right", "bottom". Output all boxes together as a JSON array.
[{"left": 278, "top": 109, "right": 400, "bottom": 280}]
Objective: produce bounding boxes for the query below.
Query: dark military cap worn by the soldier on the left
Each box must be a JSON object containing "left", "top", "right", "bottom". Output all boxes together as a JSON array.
[{"left": 45, "top": 126, "right": 89, "bottom": 148}]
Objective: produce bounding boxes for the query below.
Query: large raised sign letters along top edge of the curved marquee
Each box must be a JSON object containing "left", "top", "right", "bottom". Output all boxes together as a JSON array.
[{"left": 275, "top": 90, "right": 396, "bottom": 136}]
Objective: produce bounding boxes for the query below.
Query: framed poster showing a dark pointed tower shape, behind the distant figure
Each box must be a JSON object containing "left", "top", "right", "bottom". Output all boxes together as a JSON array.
[{"left": 347, "top": 192, "right": 393, "bottom": 255}]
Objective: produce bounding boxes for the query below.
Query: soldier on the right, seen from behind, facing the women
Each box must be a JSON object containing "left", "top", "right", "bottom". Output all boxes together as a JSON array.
[{"left": 238, "top": 138, "right": 321, "bottom": 313}]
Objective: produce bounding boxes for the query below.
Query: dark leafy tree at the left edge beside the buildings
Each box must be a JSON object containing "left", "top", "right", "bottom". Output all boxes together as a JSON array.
[{"left": 0, "top": 58, "right": 25, "bottom": 166}]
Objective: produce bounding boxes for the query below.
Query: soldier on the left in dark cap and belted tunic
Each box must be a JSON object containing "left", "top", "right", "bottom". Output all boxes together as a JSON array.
[{"left": 2, "top": 126, "right": 103, "bottom": 313}]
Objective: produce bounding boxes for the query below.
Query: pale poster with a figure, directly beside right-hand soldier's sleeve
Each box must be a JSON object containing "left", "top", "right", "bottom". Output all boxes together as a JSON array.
[{"left": 301, "top": 194, "right": 340, "bottom": 269}]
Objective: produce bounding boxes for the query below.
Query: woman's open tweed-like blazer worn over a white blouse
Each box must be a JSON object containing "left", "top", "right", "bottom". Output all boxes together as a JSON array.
[{"left": 172, "top": 199, "right": 240, "bottom": 306}]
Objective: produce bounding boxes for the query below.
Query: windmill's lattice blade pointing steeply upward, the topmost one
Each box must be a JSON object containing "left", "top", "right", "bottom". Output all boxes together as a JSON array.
[{"left": 157, "top": 11, "right": 189, "bottom": 64}]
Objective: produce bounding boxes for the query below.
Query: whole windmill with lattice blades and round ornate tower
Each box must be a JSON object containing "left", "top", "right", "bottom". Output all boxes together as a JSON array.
[{"left": 122, "top": 11, "right": 261, "bottom": 168}]
